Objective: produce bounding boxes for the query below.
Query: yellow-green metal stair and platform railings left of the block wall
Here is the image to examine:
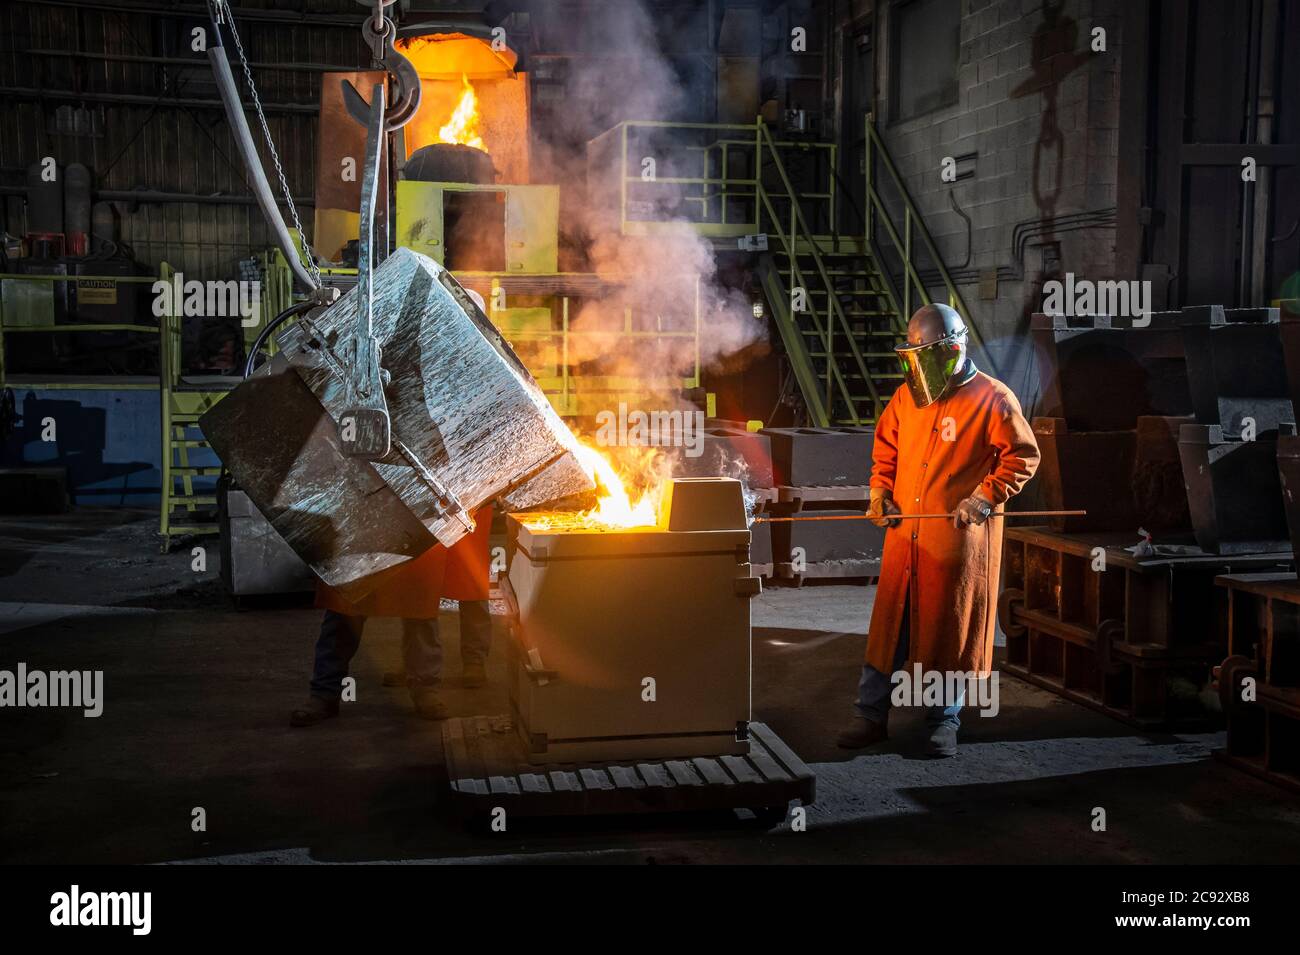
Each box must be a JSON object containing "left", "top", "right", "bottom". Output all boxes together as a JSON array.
[{"left": 593, "top": 114, "right": 992, "bottom": 424}]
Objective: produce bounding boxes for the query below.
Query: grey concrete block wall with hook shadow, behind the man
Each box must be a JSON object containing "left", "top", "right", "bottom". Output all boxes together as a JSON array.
[{"left": 878, "top": 0, "right": 1130, "bottom": 403}]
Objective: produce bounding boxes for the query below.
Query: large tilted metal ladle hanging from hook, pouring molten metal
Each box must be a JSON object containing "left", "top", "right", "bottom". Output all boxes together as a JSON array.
[{"left": 200, "top": 248, "right": 593, "bottom": 599}]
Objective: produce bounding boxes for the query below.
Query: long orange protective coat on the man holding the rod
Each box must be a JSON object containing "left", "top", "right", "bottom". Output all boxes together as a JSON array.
[{"left": 867, "top": 372, "right": 1039, "bottom": 676}]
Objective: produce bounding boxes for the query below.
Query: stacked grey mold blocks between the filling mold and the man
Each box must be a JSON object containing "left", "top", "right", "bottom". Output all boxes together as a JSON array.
[{"left": 762, "top": 426, "right": 884, "bottom": 586}]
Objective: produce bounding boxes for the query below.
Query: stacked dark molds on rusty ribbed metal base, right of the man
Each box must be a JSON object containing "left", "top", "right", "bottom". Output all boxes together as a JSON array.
[{"left": 998, "top": 307, "right": 1300, "bottom": 726}]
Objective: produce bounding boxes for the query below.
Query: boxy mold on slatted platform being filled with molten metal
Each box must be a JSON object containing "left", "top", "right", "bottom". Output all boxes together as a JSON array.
[{"left": 502, "top": 478, "right": 762, "bottom": 763}]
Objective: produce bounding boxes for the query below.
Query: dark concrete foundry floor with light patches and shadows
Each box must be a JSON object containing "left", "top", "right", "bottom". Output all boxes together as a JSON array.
[{"left": 0, "top": 509, "right": 1300, "bottom": 863}]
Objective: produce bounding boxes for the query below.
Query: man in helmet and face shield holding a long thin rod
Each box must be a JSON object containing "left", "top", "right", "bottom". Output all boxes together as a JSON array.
[{"left": 839, "top": 305, "right": 1039, "bottom": 758}]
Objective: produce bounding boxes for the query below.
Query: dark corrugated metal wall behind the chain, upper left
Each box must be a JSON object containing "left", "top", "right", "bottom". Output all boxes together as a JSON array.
[{"left": 0, "top": 0, "right": 369, "bottom": 278}]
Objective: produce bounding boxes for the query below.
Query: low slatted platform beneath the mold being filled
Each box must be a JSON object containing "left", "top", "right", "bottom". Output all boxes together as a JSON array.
[{"left": 442, "top": 716, "right": 816, "bottom": 821}]
